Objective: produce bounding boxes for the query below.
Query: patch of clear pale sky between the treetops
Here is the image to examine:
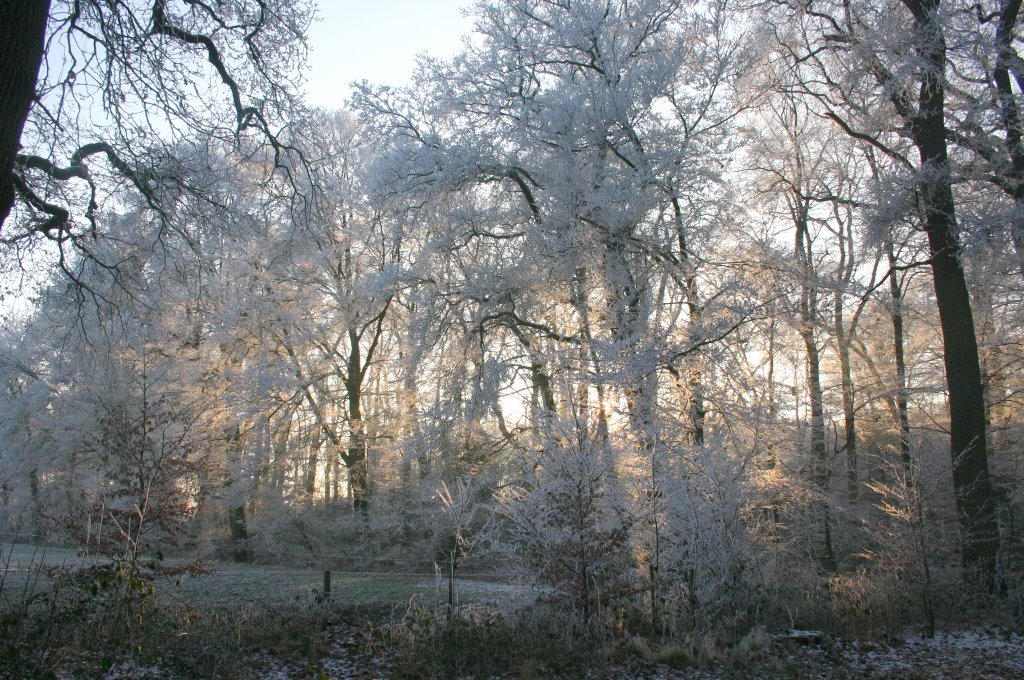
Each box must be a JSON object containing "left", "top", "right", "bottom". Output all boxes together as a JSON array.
[{"left": 306, "top": 0, "right": 473, "bottom": 109}]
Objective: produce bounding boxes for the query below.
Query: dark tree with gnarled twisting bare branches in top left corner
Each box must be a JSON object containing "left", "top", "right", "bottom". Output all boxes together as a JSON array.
[{"left": 0, "top": 0, "right": 311, "bottom": 268}]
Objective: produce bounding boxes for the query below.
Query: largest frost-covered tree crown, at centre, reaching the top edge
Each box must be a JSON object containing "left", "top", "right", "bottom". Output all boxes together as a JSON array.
[{"left": 355, "top": 0, "right": 744, "bottom": 462}]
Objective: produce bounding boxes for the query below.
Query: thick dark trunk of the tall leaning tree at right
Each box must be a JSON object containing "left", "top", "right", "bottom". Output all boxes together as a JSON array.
[{"left": 904, "top": 0, "right": 998, "bottom": 583}]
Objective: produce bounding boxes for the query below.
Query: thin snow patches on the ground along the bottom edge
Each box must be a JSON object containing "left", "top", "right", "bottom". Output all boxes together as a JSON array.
[{"left": 88, "top": 626, "right": 1024, "bottom": 680}]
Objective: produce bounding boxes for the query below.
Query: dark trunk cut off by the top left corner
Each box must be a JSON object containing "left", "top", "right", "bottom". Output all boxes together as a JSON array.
[{"left": 0, "top": 0, "right": 50, "bottom": 230}]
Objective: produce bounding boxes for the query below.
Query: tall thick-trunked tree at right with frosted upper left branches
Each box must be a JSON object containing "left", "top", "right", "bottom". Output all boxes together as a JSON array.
[{"left": 779, "top": 0, "right": 998, "bottom": 582}]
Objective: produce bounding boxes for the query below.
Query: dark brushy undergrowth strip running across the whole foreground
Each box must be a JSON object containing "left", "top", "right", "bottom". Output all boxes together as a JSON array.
[{"left": 0, "top": 540, "right": 1024, "bottom": 680}]
